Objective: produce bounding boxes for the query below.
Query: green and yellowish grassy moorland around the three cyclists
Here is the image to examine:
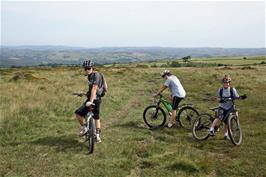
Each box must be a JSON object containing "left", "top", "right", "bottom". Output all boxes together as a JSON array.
[{"left": 0, "top": 57, "right": 266, "bottom": 177}]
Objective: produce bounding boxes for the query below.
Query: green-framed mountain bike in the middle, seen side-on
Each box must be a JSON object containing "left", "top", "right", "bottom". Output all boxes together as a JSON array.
[{"left": 143, "top": 94, "right": 199, "bottom": 129}]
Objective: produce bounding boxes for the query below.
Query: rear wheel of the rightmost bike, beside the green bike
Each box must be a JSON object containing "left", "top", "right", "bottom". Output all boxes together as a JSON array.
[{"left": 192, "top": 114, "right": 213, "bottom": 141}]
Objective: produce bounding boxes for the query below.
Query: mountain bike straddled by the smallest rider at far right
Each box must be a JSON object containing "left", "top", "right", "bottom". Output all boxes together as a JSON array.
[{"left": 192, "top": 95, "right": 246, "bottom": 146}]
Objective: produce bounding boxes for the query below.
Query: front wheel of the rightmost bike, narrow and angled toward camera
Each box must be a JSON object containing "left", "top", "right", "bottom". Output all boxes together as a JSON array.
[{"left": 227, "top": 115, "right": 242, "bottom": 146}]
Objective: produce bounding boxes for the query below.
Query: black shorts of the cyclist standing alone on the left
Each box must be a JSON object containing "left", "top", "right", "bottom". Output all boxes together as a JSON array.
[{"left": 75, "top": 99, "right": 101, "bottom": 119}]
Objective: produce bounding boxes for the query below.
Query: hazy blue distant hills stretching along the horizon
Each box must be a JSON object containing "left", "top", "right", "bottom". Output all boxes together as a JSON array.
[{"left": 0, "top": 45, "right": 266, "bottom": 67}]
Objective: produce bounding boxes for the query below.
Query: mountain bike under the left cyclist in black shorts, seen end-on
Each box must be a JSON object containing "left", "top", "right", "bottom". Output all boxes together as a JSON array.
[{"left": 73, "top": 93, "right": 96, "bottom": 153}]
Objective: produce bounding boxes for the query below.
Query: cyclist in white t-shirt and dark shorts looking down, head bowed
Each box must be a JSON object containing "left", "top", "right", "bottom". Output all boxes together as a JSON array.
[{"left": 156, "top": 70, "right": 186, "bottom": 128}]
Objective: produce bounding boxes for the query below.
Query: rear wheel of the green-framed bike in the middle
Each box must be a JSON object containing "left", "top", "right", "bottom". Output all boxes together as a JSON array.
[{"left": 177, "top": 106, "right": 199, "bottom": 130}]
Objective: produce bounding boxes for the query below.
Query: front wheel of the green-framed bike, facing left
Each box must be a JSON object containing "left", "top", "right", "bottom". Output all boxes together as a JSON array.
[{"left": 143, "top": 105, "right": 166, "bottom": 128}]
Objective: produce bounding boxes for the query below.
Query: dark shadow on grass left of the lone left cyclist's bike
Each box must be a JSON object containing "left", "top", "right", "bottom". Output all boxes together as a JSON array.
[{"left": 30, "top": 136, "right": 84, "bottom": 152}]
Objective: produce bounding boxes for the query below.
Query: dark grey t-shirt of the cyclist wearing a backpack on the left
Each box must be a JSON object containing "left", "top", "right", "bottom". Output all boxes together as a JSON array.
[{"left": 87, "top": 72, "right": 102, "bottom": 100}]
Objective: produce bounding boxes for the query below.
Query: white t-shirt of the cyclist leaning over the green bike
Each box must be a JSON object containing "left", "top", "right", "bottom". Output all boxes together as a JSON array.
[{"left": 164, "top": 75, "right": 186, "bottom": 98}]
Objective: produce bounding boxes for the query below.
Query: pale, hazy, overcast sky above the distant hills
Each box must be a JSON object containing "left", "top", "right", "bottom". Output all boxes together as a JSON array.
[{"left": 0, "top": 0, "right": 266, "bottom": 48}]
